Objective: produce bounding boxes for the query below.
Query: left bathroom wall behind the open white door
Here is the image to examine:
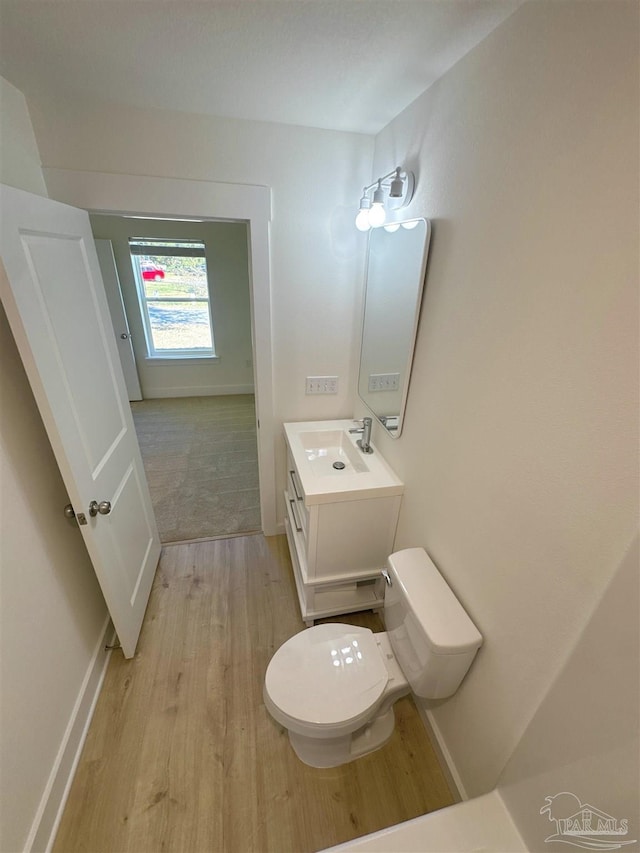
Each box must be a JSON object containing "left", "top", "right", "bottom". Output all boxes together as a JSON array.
[{"left": 0, "top": 78, "right": 107, "bottom": 851}]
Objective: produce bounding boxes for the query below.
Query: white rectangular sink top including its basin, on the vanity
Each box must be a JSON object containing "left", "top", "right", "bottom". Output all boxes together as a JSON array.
[{"left": 284, "top": 420, "right": 404, "bottom": 506}]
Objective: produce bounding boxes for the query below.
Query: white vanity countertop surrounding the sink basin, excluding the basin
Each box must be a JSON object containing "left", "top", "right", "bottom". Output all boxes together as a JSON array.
[{"left": 284, "top": 419, "right": 404, "bottom": 506}]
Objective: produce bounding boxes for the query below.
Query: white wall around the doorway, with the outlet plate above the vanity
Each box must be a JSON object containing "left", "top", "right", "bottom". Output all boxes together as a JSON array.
[{"left": 29, "top": 97, "right": 373, "bottom": 492}]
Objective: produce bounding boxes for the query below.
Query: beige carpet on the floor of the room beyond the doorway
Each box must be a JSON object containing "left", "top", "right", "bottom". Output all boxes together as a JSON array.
[{"left": 131, "top": 394, "right": 261, "bottom": 542}]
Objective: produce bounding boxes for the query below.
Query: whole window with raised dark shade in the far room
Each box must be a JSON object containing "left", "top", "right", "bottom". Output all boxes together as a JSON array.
[{"left": 129, "top": 238, "right": 215, "bottom": 358}]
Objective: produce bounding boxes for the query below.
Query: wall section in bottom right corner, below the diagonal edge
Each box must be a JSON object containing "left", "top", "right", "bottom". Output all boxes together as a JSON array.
[{"left": 499, "top": 534, "right": 640, "bottom": 853}]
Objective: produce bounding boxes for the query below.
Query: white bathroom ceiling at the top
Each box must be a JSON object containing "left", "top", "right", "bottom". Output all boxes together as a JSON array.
[{"left": 0, "top": 0, "right": 523, "bottom": 134}]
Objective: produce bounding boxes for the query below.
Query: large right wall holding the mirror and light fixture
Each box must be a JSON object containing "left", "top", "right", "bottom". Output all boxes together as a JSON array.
[{"left": 360, "top": 2, "right": 639, "bottom": 808}]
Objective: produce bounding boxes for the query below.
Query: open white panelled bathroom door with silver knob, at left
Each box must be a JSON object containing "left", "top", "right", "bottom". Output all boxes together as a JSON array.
[{"left": 0, "top": 181, "right": 160, "bottom": 657}]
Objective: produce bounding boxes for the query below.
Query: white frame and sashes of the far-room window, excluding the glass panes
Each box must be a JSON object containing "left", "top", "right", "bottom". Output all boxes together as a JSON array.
[{"left": 128, "top": 237, "right": 218, "bottom": 362}]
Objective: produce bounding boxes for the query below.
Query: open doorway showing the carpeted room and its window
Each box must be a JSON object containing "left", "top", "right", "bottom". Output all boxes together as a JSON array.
[{"left": 90, "top": 214, "right": 261, "bottom": 544}]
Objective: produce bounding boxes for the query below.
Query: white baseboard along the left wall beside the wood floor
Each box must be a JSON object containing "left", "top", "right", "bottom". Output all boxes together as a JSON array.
[{"left": 25, "top": 617, "right": 114, "bottom": 853}]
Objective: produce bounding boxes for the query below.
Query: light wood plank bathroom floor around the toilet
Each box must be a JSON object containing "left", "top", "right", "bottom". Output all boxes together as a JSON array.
[{"left": 54, "top": 534, "right": 453, "bottom": 853}]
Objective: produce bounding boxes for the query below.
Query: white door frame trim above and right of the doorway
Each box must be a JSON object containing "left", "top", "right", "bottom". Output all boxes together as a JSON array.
[{"left": 43, "top": 168, "right": 278, "bottom": 536}]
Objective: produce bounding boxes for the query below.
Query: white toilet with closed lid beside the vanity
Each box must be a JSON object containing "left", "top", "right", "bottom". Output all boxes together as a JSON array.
[{"left": 264, "top": 548, "right": 482, "bottom": 767}]
